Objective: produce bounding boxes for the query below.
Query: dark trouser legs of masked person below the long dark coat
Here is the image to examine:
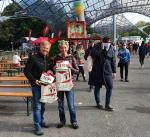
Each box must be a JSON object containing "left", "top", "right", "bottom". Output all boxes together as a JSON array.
[{"left": 94, "top": 86, "right": 112, "bottom": 107}]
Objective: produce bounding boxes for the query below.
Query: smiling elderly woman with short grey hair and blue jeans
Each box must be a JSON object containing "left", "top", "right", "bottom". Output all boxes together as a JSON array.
[{"left": 54, "top": 40, "right": 79, "bottom": 129}]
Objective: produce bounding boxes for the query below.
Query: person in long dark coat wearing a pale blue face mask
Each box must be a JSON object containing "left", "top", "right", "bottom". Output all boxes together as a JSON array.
[{"left": 89, "top": 37, "right": 116, "bottom": 111}]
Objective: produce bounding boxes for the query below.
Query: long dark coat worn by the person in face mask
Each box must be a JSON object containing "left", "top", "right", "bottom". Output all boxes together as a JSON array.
[{"left": 89, "top": 45, "right": 116, "bottom": 88}]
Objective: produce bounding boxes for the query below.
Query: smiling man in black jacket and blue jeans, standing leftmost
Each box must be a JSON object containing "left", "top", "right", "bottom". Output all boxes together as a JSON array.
[{"left": 24, "top": 41, "right": 53, "bottom": 135}]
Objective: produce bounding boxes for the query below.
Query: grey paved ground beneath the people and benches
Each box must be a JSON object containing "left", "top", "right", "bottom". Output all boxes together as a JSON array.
[{"left": 0, "top": 56, "right": 150, "bottom": 137}]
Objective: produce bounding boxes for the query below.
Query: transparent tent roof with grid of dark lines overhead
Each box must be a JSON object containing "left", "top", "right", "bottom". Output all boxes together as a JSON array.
[{"left": 0, "top": 0, "right": 150, "bottom": 35}]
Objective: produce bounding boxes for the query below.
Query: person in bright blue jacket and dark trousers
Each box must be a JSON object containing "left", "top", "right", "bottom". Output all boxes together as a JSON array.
[{"left": 118, "top": 43, "right": 130, "bottom": 82}]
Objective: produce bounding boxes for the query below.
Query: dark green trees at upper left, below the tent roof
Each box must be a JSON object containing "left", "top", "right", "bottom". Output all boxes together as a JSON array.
[{"left": 0, "top": 3, "right": 46, "bottom": 50}]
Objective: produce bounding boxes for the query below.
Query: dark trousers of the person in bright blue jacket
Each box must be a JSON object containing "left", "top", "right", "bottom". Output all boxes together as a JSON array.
[{"left": 120, "top": 63, "right": 128, "bottom": 80}]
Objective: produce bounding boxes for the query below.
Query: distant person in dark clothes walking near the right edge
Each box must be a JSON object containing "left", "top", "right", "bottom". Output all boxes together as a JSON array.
[{"left": 138, "top": 41, "right": 148, "bottom": 68}]
